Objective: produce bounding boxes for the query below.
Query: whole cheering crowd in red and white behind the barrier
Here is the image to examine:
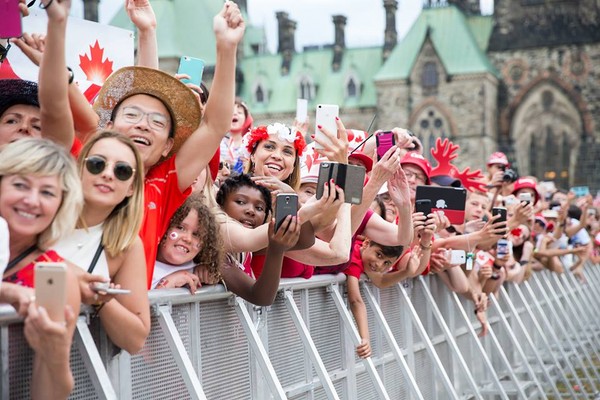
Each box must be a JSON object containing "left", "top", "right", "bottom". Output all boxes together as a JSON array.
[{"left": 0, "top": 0, "right": 600, "bottom": 398}]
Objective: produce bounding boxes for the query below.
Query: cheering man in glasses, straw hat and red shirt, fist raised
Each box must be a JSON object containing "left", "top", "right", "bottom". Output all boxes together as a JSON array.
[{"left": 94, "top": 1, "right": 244, "bottom": 287}]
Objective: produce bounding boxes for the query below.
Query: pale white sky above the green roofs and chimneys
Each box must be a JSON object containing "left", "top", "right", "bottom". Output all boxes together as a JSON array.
[{"left": 72, "top": 0, "right": 493, "bottom": 52}]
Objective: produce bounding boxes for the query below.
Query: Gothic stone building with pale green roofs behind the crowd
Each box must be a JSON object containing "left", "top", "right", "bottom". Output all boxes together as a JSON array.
[{"left": 109, "top": 0, "right": 600, "bottom": 190}]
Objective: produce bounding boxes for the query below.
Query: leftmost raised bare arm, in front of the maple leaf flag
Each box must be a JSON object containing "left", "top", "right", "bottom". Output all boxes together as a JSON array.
[{"left": 39, "top": 0, "right": 75, "bottom": 149}]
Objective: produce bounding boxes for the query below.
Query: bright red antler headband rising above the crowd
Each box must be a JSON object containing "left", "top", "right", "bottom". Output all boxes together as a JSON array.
[{"left": 431, "top": 138, "right": 486, "bottom": 192}]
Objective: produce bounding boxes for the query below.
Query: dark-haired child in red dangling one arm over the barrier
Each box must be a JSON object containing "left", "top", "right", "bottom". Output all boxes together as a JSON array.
[{"left": 344, "top": 239, "right": 404, "bottom": 358}]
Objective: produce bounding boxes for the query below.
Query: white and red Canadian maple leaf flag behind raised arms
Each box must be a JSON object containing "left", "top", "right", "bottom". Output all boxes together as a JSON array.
[{"left": 0, "top": 8, "right": 134, "bottom": 103}]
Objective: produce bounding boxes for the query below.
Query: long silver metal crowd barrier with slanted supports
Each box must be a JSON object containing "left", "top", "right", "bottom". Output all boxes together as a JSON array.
[{"left": 0, "top": 265, "right": 600, "bottom": 400}]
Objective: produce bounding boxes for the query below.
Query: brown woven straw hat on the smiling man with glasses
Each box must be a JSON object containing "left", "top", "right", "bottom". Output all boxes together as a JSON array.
[{"left": 94, "top": 67, "right": 201, "bottom": 158}]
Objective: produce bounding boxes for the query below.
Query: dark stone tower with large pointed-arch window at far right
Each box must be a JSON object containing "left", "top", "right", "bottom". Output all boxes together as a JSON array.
[{"left": 488, "top": 0, "right": 600, "bottom": 190}]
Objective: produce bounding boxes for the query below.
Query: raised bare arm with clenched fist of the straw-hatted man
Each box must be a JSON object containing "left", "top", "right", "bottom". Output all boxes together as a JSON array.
[{"left": 175, "top": 1, "right": 245, "bottom": 191}]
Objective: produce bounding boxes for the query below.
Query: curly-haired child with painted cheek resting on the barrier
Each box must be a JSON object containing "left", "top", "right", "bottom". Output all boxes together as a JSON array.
[{"left": 152, "top": 192, "right": 223, "bottom": 294}]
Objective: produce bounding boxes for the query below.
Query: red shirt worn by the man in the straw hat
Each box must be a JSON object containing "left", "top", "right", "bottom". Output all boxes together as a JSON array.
[{"left": 140, "top": 155, "right": 192, "bottom": 289}]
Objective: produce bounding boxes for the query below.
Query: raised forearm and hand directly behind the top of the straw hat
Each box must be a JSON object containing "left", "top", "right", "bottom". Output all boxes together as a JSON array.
[{"left": 125, "top": 0, "right": 158, "bottom": 69}]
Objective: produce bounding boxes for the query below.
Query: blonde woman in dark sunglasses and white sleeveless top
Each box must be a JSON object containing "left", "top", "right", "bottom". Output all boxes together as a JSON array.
[{"left": 54, "top": 132, "right": 150, "bottom": 353}]
